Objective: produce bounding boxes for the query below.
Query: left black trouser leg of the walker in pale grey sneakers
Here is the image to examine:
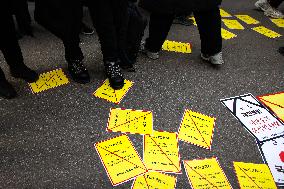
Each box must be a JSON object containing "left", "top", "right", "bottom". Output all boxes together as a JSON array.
[{"left": 146, "top": 13, "right": 174, "bottom": 52}]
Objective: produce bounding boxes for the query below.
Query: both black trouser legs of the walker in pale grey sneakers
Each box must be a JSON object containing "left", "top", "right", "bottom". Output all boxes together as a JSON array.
[{"left": 146, "top": 7, "right": 222, "bottom": 55}]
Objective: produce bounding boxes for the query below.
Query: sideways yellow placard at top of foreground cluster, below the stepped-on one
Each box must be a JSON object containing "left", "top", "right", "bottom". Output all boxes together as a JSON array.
[{"left": 107, "top": 108, "right": 153, "bottom": 135}]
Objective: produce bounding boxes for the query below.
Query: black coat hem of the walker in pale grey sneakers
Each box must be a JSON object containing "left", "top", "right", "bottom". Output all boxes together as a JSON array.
[{"left": 139, "top": 0, "right": 222, "bottom": 14}]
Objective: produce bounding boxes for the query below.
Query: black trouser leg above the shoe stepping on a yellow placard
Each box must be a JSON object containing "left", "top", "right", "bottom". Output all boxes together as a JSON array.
[{"left": 89, "top": 0, "right": 128, "bottom": 61}]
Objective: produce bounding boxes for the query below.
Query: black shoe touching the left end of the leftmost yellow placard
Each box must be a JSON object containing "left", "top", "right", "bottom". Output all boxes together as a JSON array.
[{"left": 10, "top": 64, "right": 39, "bottom": 83}]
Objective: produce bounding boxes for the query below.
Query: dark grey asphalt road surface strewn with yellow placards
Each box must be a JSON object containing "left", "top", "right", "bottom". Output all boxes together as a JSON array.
[{"left": 0, "top": 0, "right": 284, "bottom": 189}]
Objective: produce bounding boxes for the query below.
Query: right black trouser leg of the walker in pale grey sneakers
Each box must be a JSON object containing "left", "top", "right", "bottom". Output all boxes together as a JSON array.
[{"left": 193, "top": 7, "right": 222, "bottom": 55}]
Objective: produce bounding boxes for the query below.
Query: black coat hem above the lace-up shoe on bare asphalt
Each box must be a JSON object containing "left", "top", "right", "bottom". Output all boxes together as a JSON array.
[{"left": 34, "top": 0, "right": 83, "bottom": 39}]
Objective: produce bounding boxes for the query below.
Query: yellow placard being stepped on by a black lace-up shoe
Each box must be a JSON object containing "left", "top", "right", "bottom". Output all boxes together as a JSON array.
[{"left": 93, "top": 79, "right": 133, "bottom": 104}]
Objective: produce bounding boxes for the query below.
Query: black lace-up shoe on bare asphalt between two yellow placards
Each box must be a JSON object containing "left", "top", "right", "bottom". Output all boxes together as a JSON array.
[{"left": 68, "top": 60, "right": 90, "bottom": 84}]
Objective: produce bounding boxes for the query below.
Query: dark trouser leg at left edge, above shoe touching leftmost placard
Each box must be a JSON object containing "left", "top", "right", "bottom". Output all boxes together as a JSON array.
[{"left": 0, "top": 15, "right": 24, "bottom": 75}]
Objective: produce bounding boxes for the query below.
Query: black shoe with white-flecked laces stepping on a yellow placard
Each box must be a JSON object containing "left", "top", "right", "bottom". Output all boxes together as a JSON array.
[{"left": 105, "top": 61, "right": 124, "bottom": 90}]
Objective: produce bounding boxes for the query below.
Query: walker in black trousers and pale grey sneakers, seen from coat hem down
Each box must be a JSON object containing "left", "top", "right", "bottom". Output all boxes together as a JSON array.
[{"left": 139, "top": 0, "right": 224, "bottom": 65}]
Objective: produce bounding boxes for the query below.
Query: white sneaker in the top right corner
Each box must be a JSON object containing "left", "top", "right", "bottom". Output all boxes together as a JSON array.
[{"left": 254, "top": 0, "right": 284, "bottom": 18}]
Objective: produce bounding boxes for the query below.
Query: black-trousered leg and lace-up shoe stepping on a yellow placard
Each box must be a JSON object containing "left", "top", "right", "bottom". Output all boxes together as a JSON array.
[{"left": 89, "top": 0, "right": 126, "bottom": 89}]
